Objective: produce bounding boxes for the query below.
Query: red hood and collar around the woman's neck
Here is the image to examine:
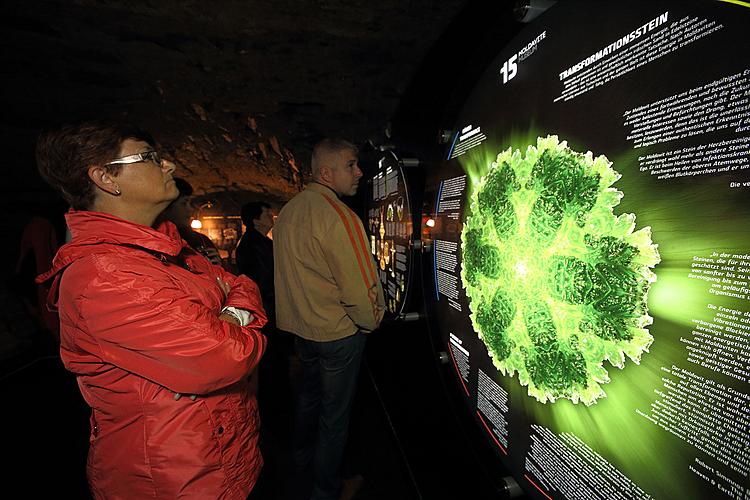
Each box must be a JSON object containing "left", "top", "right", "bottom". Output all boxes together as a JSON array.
[{"left": 36, "top": 210, "right": 186, "bottom": 283}]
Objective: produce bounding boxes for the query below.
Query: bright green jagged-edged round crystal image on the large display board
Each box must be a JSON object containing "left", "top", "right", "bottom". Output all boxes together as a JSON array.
[{"left": 461, "top": 136, "right": 660, "bottom": 405}]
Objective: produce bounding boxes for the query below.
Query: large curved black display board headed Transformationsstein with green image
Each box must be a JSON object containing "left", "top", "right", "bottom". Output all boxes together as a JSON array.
[{"left": 424, "top": 1, "right": 750, "bottom": 499}]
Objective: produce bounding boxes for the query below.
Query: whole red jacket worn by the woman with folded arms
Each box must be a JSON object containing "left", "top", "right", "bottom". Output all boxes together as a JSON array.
[{"left": 37, "top": 211, "right": 266, "bottom": 499}]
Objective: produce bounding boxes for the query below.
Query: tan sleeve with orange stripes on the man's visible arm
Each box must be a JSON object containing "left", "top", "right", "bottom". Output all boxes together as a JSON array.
[{"left": 321, "top": 212, "right": 385, "bottom": 331}]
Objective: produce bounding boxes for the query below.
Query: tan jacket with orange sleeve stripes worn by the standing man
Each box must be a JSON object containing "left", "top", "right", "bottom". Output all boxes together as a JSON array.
[{"left": 273, "top": 183, "right": 385, "bottom": 342}]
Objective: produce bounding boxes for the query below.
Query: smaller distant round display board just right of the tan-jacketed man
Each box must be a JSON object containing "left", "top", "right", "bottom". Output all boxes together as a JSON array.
[{"left": 367, "top": 151, "right": 413, "bottom": 317}]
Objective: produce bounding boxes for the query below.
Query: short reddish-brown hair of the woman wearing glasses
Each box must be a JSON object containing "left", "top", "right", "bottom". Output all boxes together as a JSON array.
[{"left": 36, "top": 121, "right": 155, "bottom": 210}]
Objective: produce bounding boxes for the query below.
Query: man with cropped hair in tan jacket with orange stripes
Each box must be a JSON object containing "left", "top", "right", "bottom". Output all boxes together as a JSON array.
[{"left": 273, "top": 139, "right": 384, "bottom": 500}]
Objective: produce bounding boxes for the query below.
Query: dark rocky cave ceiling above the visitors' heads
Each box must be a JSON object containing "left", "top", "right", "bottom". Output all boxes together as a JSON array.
[{"left": 0, "top": 0, "right": 478, "bottom": 207}]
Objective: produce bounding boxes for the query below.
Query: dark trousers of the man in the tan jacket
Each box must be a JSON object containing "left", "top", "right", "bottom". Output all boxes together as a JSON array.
[{"left": 293, "top": 332, "right": 367, "bottom": 500}]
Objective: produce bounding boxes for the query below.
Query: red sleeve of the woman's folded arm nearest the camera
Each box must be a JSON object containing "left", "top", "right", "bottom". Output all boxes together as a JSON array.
[{"left": 66, "top": 258, "right": 266, "bottom": 394}]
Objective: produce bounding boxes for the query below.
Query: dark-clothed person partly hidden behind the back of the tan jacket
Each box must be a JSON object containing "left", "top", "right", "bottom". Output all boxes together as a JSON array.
[{"left": 235, "top": 201, "right": 275, "bottom": 326}]
